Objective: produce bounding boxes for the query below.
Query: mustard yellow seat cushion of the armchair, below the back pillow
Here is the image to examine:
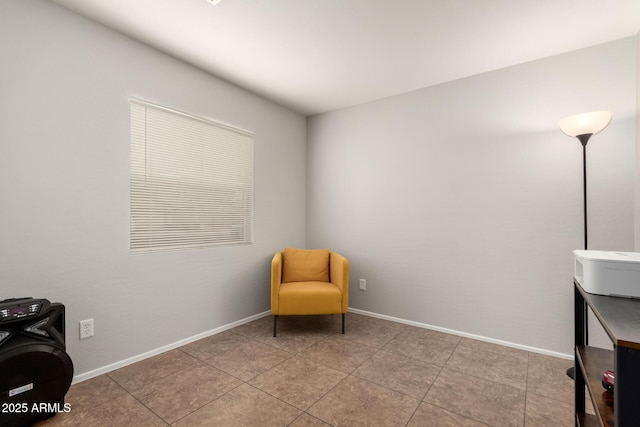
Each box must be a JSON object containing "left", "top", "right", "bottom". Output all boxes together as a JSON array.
[{"left": 279, "top": 281, "right": 343, "bottom": 315}]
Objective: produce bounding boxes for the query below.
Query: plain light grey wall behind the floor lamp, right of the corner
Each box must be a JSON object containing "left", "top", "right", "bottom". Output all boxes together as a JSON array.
[{"left": 307, "top": 38, "right": 637, "bottom": 355}]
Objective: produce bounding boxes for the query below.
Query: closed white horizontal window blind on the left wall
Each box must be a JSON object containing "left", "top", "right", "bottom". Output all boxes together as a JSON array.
[{"left": 130, "top": 100, "right": 253, "bottom": 254}]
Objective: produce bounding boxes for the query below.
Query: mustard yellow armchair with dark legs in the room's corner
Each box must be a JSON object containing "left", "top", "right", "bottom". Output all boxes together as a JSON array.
[{"left": 271, "top": 248, "right": 349, "bottom": 337}]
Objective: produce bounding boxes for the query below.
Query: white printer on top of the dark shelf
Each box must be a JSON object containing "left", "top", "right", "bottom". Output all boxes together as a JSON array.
[{"left": 573, "top": 250, "right": 640, "bottom": 298}]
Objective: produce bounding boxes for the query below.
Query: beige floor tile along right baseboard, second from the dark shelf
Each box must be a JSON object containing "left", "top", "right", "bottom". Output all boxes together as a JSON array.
[{"left": 445, "top": 345, "right": 527, "bottom": 390}]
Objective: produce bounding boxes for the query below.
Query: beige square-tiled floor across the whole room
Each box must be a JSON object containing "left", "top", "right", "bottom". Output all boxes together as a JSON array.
[{"left": 37, "top": 313, "right": 574, "bottom": 427}]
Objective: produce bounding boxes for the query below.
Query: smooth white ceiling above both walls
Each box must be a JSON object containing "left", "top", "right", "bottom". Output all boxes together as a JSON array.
[{"left": 53, "top": 0, "right": 640, "bottom": 115}]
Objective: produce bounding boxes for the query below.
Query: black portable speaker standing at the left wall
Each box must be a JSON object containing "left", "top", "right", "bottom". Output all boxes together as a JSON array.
[{"left": 0, "top": 298, "right": 73, "bottom": 427}]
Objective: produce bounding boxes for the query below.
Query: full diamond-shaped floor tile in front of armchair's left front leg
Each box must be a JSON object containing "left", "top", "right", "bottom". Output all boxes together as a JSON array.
[{"left": 250, "top": 357, "right": 347, "bottom": 410}]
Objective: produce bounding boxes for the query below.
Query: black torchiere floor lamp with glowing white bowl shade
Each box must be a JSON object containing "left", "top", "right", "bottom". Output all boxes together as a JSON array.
[{"left": 558, "top": 111, "right": 611, "bottom": 379}]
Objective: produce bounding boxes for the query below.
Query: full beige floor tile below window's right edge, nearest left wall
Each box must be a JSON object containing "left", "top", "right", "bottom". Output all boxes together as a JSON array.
[{"left": 207, "top": 340, "right": 291, "bottom": 381}]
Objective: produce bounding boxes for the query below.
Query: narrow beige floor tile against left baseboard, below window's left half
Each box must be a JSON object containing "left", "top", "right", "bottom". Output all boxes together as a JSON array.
[{"left": 107, "top": 349, "right": 196, "bottom": 391}]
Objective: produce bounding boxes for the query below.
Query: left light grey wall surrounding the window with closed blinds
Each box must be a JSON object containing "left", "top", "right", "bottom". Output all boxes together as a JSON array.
[{"left": 0, "top": 0, "right": 306, "bottom": 374}]
